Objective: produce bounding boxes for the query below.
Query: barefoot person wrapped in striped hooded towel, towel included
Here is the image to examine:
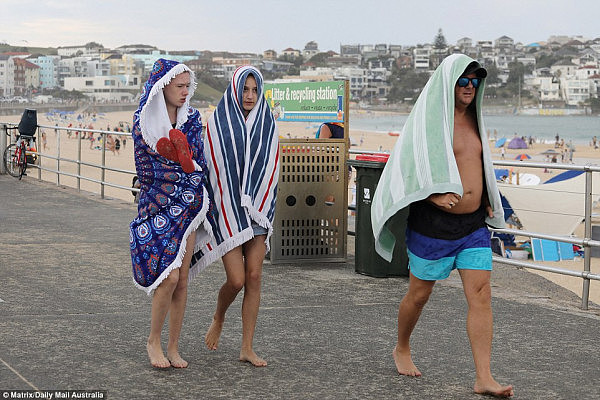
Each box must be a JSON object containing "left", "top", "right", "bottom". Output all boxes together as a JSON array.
[{"left": 204, "top": 66, "right": 279, "bottom": 367}]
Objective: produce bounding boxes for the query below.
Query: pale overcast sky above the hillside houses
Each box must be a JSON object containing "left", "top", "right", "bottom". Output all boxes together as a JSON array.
[{"left": 0, "top": 0, "right": 600, "bottom": 53}]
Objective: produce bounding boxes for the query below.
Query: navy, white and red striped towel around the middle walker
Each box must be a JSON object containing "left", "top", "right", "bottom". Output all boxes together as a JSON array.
[{"left": 196, "top": 66, "right": 279, "bottom": 259}]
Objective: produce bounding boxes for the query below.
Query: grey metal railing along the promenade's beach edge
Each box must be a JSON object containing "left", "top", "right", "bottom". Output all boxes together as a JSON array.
[{"left": 0, "top": 124, "right": 600, "bottom": 310}]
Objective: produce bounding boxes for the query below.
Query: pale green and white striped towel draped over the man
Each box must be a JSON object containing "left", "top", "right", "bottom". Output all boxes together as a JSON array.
[{"left": 371, "top": 54, "right": 504, "bottom": 261}]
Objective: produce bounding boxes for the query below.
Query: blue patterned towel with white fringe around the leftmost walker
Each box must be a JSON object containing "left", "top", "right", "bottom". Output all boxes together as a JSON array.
[{"left": 129, "top": 59, "right": 214, "bottom": 295}]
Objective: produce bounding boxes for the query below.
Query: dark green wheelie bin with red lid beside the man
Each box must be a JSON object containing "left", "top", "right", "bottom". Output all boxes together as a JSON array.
[{"left": 348, "top": 155, "right": 408, "bottom": 278}]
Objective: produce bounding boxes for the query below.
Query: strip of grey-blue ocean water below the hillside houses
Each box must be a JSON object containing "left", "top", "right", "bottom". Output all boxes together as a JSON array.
[{"left": 350, "top": 114, "right": 600, "bottom": 144}]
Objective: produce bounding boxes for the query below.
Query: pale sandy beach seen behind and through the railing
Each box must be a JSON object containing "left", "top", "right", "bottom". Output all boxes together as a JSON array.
[{"left": 0, "top": 110, "right": 600, "bottom": 304}]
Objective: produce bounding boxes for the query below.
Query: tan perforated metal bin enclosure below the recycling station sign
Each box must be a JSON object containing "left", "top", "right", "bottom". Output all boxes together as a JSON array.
[{"left": 271, "top": 139, "right": 348, "bottom": 264}]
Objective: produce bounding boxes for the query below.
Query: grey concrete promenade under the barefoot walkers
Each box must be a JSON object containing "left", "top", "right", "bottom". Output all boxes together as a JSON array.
[{"left": 0, "top": 175, "right": 600, "bottom": 400}]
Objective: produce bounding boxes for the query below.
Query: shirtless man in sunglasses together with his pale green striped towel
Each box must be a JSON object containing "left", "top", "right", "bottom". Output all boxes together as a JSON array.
[{"left": 371, "top": 54, "right": 513, "bottom": 397}]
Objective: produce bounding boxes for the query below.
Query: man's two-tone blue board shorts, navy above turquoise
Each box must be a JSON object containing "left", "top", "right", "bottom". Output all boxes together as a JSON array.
[{"left": 406, "top": 227, "right": 492, "bottom": 281}]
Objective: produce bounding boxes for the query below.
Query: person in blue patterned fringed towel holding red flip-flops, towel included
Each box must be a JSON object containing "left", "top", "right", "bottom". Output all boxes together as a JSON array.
[{"left": 129, "top": 59, "right": 214, "bottom": 368}]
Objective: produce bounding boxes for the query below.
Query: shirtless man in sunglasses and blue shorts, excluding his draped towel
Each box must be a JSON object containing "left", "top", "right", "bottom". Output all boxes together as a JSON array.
[{"left": 393, "top": 63, "right": 513, "bottom": 397}]
